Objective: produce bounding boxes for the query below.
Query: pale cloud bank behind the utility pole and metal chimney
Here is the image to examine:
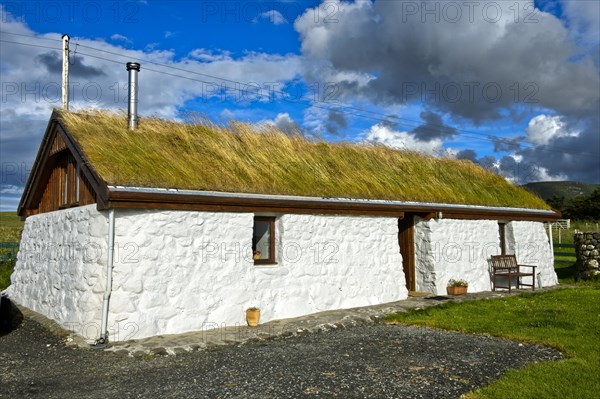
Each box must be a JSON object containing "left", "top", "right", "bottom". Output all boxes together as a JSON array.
[{"left": 0, "top": 5, "right": 301, "bottom": 210}]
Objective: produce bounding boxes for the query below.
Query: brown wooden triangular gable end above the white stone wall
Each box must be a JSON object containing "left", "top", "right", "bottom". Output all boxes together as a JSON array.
[{"left": 18, "top": 114, "right": 106, "bottom": 218}]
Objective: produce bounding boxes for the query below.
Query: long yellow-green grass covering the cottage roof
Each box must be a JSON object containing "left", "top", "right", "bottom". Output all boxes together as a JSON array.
[{"left": 62, "top": 111, "right": 549, "bottom": 209}]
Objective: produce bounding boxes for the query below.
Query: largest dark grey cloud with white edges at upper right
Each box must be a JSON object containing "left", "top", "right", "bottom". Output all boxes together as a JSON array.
[{"left": 294, "top": 0, "right": 600, "bottom": 123}]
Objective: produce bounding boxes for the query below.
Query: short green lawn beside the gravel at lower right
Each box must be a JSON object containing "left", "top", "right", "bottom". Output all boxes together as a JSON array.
[{"left": 388, "top": 276, "right": 600, "bottom": 399}]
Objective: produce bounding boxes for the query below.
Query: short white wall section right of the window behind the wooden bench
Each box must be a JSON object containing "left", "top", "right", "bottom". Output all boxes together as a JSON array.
[{"left": 506, "top": 222, "right": 558, "bottom": 288}]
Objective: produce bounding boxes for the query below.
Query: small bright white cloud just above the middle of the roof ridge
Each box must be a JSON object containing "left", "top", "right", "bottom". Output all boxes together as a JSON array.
[{"left": 364, "top": 124, "right": 443, "bottom": 155}]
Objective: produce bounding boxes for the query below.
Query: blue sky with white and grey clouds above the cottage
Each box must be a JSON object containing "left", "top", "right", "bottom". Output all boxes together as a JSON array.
[{"left": 0, "top": 0, "right": 600, "bottom": 210}]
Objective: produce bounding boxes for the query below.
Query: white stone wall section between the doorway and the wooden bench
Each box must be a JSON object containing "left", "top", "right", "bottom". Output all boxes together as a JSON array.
[{"left": 415, "top": 218, "right": 500, "bottom": 294}]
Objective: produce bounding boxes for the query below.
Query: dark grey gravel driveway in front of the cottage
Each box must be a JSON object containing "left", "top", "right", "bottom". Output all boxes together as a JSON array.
[{"left": 0, "top": 319, "right": 561, "bottom": 399}]
